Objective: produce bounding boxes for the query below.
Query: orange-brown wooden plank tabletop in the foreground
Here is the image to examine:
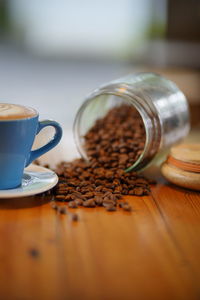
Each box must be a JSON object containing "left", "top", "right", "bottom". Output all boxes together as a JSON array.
[{"left": 0, "top": 131, "right": 200, "bottom": 300}]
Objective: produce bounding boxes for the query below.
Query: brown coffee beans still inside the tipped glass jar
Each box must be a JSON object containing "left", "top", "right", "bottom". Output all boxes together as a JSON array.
[{"left": 84, "top": 104, "right": 145, "bottom": 169}]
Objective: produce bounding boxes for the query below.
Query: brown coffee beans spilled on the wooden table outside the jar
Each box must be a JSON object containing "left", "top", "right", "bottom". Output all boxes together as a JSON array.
[{"left": 53, "top": 159, "right": 150, "bottom": 211}]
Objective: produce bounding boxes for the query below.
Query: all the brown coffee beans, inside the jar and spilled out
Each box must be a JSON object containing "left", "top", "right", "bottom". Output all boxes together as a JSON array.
[{"left": 49, "top": 105, "right": 153, "bottom": 211}]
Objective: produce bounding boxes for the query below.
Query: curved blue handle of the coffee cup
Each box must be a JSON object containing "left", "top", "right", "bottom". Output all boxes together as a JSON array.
[{"left": 26, "top": 120, "right": 62, "bottom": 167}]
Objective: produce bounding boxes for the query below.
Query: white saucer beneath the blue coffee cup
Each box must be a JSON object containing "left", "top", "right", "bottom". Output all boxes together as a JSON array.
[{"left": 0, "top": 164, "right": 58, "bottom": 199}]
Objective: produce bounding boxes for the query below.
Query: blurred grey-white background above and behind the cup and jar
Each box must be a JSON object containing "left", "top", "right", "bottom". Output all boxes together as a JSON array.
[{"left": 0, "top": 0, "right": 200, "bottom": 162}]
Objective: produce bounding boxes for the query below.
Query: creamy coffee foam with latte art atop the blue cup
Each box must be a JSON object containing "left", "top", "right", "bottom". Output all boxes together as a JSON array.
[{"left": 0, "top": 103, "right": 38, "bottom": 121}]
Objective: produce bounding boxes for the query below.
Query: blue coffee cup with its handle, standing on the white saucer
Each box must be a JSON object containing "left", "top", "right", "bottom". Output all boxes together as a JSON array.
[{"left": 0, "top": 104, "right": 62, "bottom": 190}]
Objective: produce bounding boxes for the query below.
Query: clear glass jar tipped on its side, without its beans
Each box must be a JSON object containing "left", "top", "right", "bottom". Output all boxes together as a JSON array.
[{"left": 74, "top": 73, "right": 190, "bottom": 171}]
